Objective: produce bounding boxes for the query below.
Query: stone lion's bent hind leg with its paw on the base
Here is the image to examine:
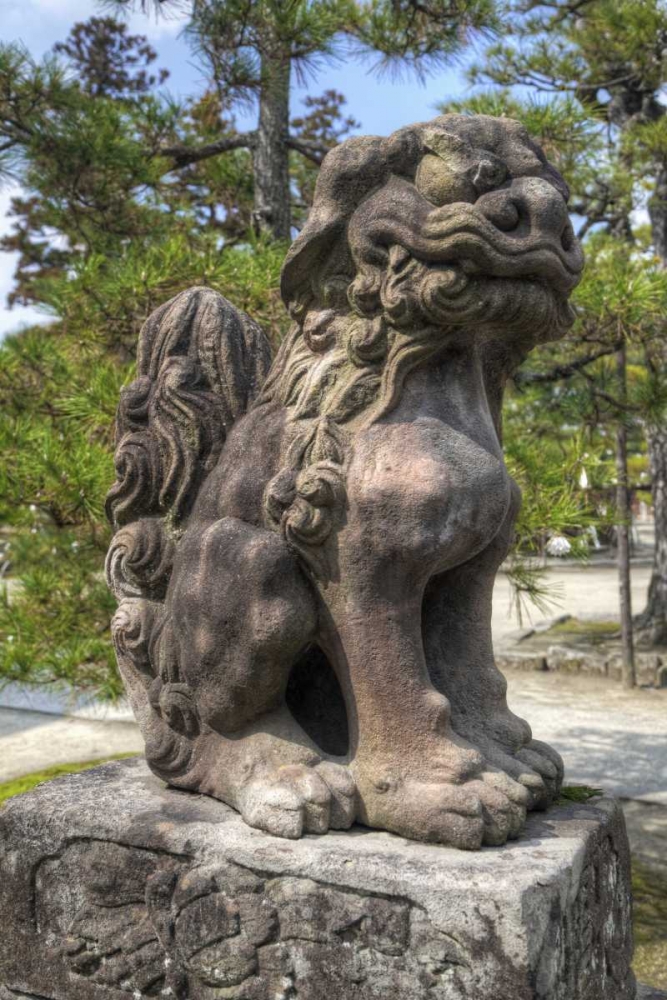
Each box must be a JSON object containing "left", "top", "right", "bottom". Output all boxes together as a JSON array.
[{"left": 114, "top": 518, "right": 355, "bottom": 837}]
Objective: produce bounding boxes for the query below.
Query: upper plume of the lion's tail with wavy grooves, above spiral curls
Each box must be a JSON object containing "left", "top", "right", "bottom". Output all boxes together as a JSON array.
[{"left": 107, "top": 288, "right": 271, "bottom": 531}]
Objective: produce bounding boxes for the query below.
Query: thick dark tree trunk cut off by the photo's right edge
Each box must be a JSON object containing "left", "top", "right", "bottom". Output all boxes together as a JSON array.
[{"left": 635, "top": 162, "right": 667, "bottom": 645}]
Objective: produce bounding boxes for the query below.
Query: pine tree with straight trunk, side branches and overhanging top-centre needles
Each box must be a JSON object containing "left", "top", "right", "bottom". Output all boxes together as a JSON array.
[{"left": 108, "top": 0, "right": 495, "bottom": 239}]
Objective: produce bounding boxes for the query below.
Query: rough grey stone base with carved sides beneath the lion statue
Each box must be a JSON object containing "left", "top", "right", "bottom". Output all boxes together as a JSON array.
[{"left": 0, "top": 759, "right": 635, "bottom": 1000}]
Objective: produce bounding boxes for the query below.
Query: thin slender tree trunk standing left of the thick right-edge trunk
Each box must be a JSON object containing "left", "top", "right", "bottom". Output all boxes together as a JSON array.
[{"left": 616, "top": 347, "right": 637, "bottom": 688}]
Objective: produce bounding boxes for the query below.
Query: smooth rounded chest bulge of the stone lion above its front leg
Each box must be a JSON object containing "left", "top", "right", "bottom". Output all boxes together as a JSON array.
[{"left": 348, "top": 417, "right": 511, "bottom": 572}]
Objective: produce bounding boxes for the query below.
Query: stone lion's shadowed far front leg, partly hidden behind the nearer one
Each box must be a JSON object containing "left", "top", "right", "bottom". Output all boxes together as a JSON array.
[{"left": 422, "top": 488, "right": 563, "bottom": 809}]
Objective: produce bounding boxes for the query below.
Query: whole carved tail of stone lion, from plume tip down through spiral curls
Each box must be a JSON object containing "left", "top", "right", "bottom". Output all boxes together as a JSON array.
[{"left": 106, "top": 288, "right": 271, "bottom": 776}]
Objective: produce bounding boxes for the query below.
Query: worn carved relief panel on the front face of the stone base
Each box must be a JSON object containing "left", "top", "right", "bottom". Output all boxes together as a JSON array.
[{"left": 35, "top": 840, "right": 470, "bottom": 1000}]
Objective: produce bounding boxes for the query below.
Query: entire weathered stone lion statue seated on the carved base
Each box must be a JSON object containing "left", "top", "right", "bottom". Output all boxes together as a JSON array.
[{"left": 107, "top": 115, "right": 582, "bottom": 849}]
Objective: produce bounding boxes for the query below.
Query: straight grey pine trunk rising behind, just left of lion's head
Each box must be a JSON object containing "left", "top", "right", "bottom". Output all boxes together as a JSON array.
[{"left": 253, "top": 52, "right": 291, "bottom": 240}]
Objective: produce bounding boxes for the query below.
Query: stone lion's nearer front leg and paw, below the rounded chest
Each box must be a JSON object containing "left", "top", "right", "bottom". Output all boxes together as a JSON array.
[{"left": 321, "top": 546, "right": 527, "bottom": 849}]
